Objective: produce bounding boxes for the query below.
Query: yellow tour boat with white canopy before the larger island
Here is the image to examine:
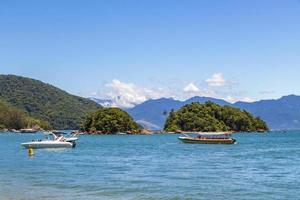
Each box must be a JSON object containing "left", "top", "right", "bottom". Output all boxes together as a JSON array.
[{"left": 178, "top": 132, "right": 236, "bottom": 144}]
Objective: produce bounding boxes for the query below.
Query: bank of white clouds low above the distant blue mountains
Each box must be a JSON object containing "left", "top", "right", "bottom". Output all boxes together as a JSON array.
[{"left": 92, "top": 76, "right": 253, "bottom": 108}]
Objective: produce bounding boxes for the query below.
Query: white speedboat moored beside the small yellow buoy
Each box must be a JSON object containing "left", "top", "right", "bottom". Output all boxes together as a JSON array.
[{"left": 22, "top": 133, "right": 77, "bottom": 149}]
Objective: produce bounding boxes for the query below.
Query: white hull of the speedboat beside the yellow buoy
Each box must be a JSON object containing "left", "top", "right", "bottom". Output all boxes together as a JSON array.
[{"left": 22, "top": 141, "right": 75, "bottom": 149}]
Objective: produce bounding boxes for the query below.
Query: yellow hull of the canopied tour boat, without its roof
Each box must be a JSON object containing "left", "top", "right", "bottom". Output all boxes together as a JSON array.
[{"left": 178, "top": 137, "right": 236, "bottom": 144}]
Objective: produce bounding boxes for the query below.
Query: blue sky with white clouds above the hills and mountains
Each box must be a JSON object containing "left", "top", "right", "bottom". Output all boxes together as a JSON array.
[{"left": 0, "top": 0, "right": 300, "bottom": 107}]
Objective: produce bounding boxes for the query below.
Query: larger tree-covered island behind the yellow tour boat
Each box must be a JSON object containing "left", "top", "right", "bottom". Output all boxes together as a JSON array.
[{"left": 164, "top": 102, "right": 269, "bottom": 132}]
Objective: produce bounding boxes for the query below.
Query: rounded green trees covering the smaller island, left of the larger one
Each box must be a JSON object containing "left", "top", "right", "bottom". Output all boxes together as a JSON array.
[{"left": 82, "top": 108, "right": 139, "bottom": 134}]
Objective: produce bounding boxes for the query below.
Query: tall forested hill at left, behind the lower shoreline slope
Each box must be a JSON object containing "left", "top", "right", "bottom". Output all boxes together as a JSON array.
[{"left": 0, "top": 75, "right": 101, "bottom": 129}]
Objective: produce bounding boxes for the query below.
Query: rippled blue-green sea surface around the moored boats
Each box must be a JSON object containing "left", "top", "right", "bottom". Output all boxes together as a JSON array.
[{"left": 0, "top": 131, "right": 300, "bottom": 200}]
